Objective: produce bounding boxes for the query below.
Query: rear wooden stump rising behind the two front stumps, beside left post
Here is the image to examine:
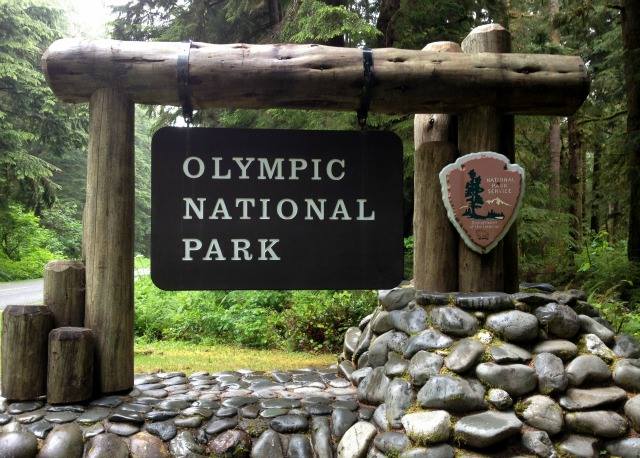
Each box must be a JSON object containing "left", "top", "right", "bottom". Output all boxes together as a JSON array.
[{"left": 44, "top": 261, "right": 85, "bottom": 328}]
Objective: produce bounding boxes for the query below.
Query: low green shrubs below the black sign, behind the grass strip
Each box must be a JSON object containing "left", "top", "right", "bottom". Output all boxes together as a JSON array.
[{"left": 135, "top": 277, "right": 376, "bottom": 351}]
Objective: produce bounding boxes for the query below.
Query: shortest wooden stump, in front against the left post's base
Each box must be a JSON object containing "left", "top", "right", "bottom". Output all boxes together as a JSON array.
[{"left": 47, "top": 327, "right": 93, "bottom": 404}]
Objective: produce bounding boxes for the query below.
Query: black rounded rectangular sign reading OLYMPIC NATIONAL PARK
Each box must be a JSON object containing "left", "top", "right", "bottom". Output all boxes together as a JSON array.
[{"left": 151, "top": 127, "right": 403, "bottom": 290}]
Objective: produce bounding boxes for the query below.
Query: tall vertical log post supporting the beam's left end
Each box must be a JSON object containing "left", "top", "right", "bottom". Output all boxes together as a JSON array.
[{"left": 83, "top": 88, "right": 134, "bottom": 393}]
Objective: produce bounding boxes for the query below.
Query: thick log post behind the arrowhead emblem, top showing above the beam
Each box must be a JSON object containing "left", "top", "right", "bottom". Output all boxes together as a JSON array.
[{"left": 458, "top": 24, "right": 513, "bottom": 291}]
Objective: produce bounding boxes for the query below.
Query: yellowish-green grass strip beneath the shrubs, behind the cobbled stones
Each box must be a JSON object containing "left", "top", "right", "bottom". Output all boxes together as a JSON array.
[{"left": 134, "top": 341, "right": 337, "bottom": 374}]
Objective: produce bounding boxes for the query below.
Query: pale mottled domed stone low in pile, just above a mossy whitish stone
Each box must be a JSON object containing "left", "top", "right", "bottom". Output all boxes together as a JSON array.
[{"left": 418, "top": 375, "right": 486, "bottom": 412}]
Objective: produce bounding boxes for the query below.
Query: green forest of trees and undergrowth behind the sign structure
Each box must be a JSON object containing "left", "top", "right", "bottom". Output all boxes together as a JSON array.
[{"left": 0, "top": 0, "right": 640, "bottom": 351}]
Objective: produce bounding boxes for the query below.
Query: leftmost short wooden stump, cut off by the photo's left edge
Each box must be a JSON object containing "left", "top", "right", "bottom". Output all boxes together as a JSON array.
[{"left": 2, "top": 305, "right": 53, "bottom": 401}]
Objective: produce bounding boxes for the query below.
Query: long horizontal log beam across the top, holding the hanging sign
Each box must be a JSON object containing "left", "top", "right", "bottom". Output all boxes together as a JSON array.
[{"left": 42, "top": 39, "right": 589, "bottom": 115}]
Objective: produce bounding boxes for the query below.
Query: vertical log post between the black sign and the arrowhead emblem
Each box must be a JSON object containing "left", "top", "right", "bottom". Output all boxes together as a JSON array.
[{"left": 413, "top": 41, "right": 462, "bottom": 292}]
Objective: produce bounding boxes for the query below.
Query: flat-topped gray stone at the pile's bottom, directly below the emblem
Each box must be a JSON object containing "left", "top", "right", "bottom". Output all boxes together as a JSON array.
[{"left": 455, "top": 411, "right": 522, "bottom": 448}]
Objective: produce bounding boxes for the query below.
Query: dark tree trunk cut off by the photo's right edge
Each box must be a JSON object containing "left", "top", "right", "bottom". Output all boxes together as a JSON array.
[{"left": 622, "top": 0, "right": 640, "bottom": 263}]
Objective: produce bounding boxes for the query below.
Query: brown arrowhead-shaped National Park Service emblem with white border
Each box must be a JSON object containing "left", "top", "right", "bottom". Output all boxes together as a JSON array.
[{"left": 440, "top": 152, "right": 524, "bottom": 254}]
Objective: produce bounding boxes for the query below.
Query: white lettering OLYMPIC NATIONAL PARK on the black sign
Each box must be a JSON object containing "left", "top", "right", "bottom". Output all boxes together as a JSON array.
[{"left": 182, "top": 156, "right": 376, "bottom": 262}]
